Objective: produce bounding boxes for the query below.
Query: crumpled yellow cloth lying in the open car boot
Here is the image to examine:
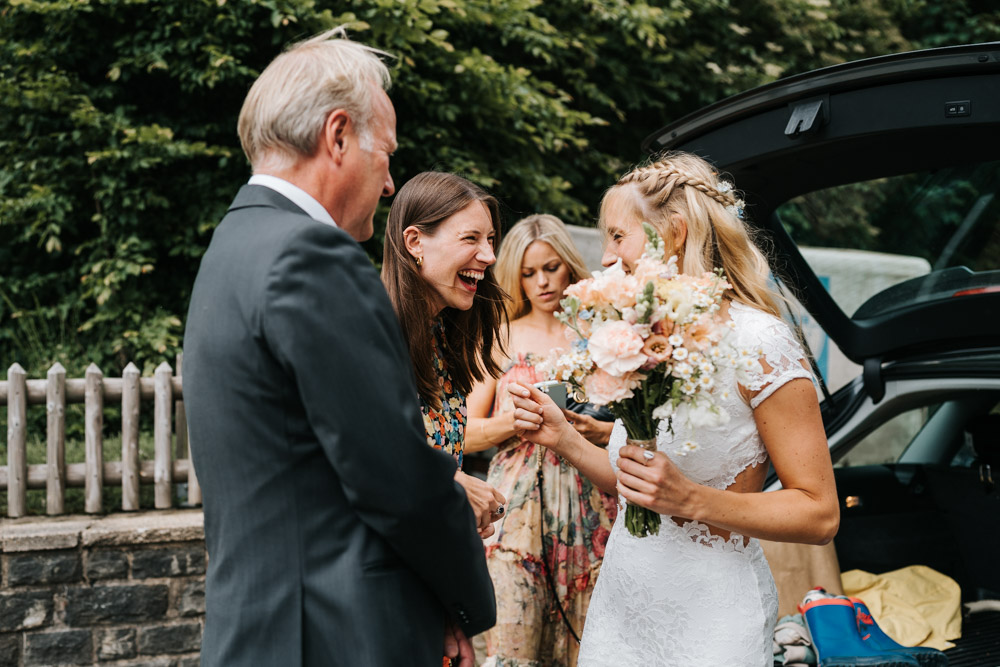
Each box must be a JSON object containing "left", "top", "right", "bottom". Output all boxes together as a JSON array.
[{"left": 840, "top": 565, "right": 962, "bottom": 651}]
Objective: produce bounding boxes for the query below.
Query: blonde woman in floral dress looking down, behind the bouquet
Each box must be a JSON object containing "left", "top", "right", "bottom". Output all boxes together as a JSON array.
[{"left": 465, "top": 215, "right": 616, "bottom": 667}]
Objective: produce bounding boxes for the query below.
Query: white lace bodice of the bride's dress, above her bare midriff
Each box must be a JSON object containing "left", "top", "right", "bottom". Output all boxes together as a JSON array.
[{"left": 608, "top": 302, "right": 812, "bottom": 489}]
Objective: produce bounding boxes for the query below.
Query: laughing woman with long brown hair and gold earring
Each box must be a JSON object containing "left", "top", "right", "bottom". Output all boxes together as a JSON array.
[{"left": 382, "top": 172, "right": 506, "bottom": 537}]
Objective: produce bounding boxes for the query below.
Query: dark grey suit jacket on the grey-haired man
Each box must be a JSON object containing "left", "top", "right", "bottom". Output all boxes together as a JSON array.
[{"left": 183, "top": 185, "right": 496, "bottom": 667}]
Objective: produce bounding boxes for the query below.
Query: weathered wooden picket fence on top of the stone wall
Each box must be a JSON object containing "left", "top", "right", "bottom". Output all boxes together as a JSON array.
[{"left": 0, "top": 355, "right": 201, "bottom": 518}]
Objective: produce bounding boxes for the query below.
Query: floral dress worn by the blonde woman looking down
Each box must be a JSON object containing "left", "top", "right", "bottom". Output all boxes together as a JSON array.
[{"left": 484, "top": 354, "right": 617, "bottom": 667}]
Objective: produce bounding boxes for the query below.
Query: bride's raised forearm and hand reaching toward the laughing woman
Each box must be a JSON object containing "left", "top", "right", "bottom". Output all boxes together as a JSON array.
[{"left": 507, "top": 382, "right": 618, "bottom": 495}]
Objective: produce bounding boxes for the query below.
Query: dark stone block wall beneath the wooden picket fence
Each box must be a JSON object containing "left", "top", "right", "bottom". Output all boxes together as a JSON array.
[{"left": 0, "top": 510, "right": 206, "bottom": 667}]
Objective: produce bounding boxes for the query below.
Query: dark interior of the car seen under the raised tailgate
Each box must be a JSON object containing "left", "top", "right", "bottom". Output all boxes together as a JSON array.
[{"left": 834, "top": 390, "right": 1000, "bottom": 601}]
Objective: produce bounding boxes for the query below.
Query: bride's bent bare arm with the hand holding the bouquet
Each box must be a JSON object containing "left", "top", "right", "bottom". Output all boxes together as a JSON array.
[{"left": 618, "top": 378, "right": 840, "bottom": 544}]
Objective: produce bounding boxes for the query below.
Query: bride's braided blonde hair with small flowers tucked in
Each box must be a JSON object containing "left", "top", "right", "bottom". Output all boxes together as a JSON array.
[{"left": 600, "top": 152, "right": 782, "bottom": 316}]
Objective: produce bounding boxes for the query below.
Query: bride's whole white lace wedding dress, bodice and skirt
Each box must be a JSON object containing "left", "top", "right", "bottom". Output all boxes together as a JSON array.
[{"left": 578, "top": 303, "right": 812, "bottom": 667}]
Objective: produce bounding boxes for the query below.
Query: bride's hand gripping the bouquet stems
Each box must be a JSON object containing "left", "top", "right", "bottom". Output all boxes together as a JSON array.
[{"left": 618, "top": 445, "right": 698, "bottom": 517}]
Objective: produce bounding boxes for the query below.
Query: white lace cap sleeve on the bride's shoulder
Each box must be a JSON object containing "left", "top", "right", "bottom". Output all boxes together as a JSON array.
[{"left": 733, "top": 304, "right": 813, "bottom": 409}]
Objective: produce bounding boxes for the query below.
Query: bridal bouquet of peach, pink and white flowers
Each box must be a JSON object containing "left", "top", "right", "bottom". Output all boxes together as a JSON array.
[{"left": 549, "top": 223, "right": 758, "bottom": 537}]
